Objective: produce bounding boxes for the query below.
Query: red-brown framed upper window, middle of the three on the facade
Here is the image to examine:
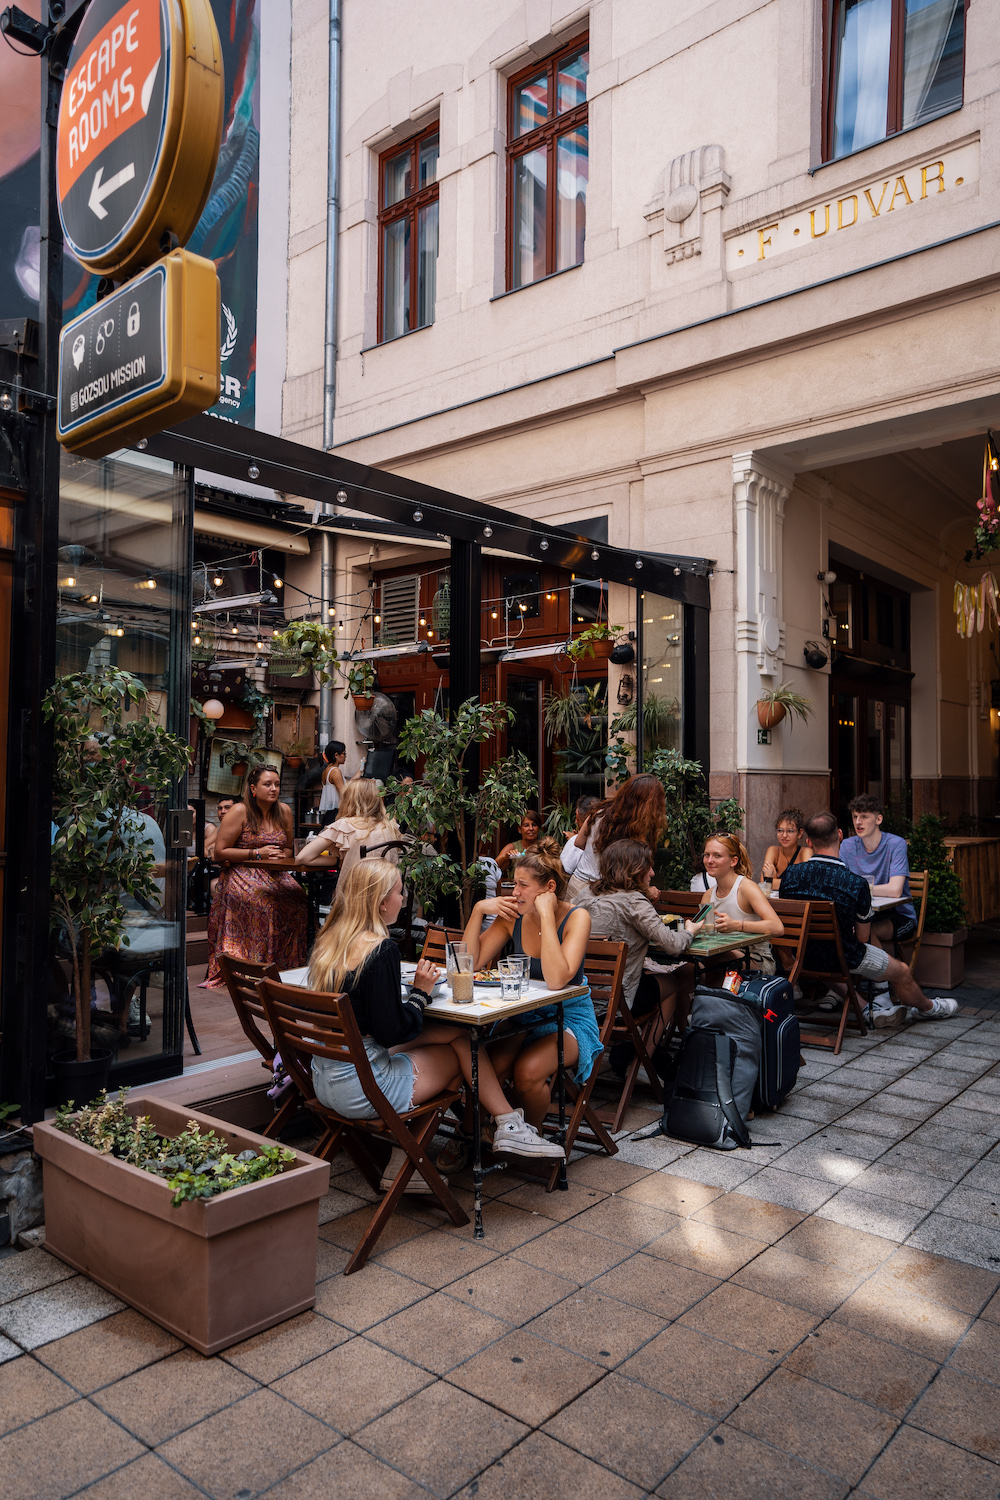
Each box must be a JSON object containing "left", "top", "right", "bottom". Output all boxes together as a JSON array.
[{"left": 507, "top": 36, "right": 591, "bottom": 291}]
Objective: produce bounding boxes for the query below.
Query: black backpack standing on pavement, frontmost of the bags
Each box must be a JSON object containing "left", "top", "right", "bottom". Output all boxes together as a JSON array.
[{"left": 660, "top": 1026, "right": 750, "bottom": 1151}]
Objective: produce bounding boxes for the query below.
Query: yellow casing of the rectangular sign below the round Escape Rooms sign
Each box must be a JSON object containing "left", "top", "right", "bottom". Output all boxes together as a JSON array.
[{"left": 58, "top": 251, "right": 222, "bottom": 459}]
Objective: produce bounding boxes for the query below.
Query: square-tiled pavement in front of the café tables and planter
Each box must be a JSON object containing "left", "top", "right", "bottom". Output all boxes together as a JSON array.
[{"left": 0, "top": 1011, "right": 1000, "bottom": 1500}]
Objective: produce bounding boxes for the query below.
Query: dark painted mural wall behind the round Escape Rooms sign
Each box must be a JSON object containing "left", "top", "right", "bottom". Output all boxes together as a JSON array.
[{"left": 0, "top": 0, "right": 262, "bottom": 428}]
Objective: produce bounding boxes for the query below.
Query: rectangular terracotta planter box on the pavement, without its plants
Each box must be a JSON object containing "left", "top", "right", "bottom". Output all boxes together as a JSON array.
[{"left": 34, "top": 1097, "right": 330, "bottom": 1355}]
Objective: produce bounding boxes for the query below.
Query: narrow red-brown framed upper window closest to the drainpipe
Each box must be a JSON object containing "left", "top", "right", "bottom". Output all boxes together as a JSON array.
[{"left": 378, "top": 122, "right": 438, "bottom": 344}]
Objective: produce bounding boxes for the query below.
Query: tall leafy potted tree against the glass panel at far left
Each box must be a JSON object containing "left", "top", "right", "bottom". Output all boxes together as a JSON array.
[{"left": 43, "top": 668, "right": 190, "bottom": 1101}]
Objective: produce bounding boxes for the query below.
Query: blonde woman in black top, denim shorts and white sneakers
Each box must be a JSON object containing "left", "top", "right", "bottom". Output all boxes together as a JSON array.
[{"left": 309, "top": 864, "right": 564, "bottom": 1193}]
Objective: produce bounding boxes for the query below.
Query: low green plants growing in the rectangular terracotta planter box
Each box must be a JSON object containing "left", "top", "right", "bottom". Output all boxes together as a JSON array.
[{"left": 55, "top": 1089, "right": 295, "bottom": 1205}]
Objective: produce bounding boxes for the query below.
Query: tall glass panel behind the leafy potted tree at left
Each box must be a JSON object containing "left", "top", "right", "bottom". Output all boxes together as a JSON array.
[{"left": 56, "top": 453, "right": 190, "bottom": 1082}]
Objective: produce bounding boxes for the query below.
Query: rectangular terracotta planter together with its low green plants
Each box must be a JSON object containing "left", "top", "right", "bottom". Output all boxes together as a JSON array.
[{"left": 34, "top": 1094, "right": 330, "bottom": 1355}]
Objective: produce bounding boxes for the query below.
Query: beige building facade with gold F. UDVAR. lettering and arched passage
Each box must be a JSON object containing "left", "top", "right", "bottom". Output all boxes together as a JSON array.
[{"left": 275, "top": 0, "right": 1000, "bottom": 854}]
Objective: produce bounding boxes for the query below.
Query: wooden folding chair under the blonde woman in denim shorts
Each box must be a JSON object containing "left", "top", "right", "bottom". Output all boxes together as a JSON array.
[{"left": 259, "top": 980, "right": 469, "bottom": 1277}]
